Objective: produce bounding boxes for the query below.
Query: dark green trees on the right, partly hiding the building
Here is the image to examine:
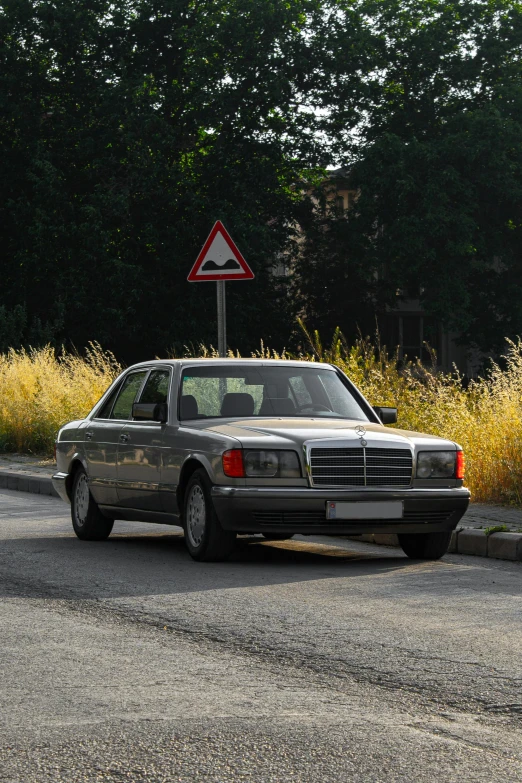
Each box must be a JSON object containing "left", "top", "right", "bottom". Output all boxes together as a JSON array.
[{"left": 296, "top": 0, "right": 522, "bottom": 350}]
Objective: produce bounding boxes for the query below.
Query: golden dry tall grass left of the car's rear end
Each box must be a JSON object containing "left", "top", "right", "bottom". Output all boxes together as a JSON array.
[{"left": 0, "top": 343, "right": 122, "bottom": 454}]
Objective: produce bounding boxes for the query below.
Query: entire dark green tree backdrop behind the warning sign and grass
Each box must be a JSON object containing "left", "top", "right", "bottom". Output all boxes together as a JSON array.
[{"left": 0, "top": 0, "right": 522, "bottom": 360}]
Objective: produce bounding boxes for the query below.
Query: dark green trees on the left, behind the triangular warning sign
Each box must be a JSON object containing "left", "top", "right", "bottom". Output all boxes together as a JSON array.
[{"left": 0, "top": 0, "right": 332, "bottom": 360}]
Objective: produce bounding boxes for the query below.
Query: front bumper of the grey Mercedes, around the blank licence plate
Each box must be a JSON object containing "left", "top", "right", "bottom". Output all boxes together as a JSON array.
[{"left": 212, "top": 486, "right": 470, "bottom": 535}]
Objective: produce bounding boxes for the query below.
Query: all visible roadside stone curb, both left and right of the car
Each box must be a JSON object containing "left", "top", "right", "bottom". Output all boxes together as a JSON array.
[{"left": 0, "top": 470, "right": 522, "bottom": 562}]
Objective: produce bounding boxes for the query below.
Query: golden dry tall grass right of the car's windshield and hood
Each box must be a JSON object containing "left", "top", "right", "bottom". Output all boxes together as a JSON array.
[{"left": 288, "top": 331, "right": 522, "bottom": 506}]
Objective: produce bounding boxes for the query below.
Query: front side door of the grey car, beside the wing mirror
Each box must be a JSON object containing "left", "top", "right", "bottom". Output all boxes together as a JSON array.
[{"left": 117, "top": 367, "right": 170, "bottom": 511}]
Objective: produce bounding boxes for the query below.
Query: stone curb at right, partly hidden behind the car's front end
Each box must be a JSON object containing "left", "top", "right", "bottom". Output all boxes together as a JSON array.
[{"left": 347, "top": 528, "right": 522, "bottom": 562}]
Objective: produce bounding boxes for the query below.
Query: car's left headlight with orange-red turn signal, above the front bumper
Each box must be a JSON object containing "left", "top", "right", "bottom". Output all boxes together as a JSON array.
[{"left": 222, "top": 449, "right": 301, "bottom": 478}]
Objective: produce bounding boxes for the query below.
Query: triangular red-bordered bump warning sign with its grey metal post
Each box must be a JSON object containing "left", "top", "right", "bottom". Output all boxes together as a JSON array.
[{"left": 187, "top": 220, "right": 254, "bottom": 357}]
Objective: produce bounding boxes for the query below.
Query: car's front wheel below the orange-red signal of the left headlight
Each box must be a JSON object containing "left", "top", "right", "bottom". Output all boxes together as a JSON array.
[{"left": 183, "top": 470, "right": 236, "bottom": 562}]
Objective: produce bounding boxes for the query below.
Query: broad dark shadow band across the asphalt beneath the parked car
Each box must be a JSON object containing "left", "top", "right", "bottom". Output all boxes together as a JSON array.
[{"left": 0, "top": 490, "right": 522, "bottom": 602}]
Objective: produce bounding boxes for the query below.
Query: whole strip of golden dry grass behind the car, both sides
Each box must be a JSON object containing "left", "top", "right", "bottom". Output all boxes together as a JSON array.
[{"left": 0, "top": 332, "right": 522, "bottom": 505}]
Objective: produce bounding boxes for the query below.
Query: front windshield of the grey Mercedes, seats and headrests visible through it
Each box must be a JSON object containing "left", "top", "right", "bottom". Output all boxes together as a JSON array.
[{"left": 180, "top": 364, "right": 368, "bottom": 421}]
